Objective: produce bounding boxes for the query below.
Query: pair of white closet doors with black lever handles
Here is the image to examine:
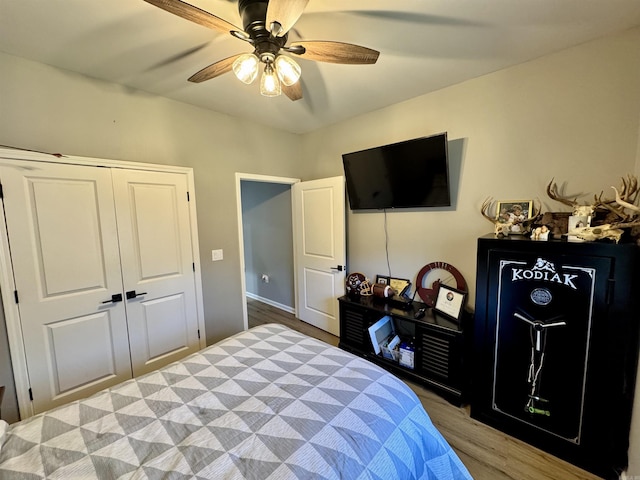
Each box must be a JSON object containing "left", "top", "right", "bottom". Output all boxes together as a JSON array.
[{"left": 0, "top": 162, "right": 199, "bottom": 413}]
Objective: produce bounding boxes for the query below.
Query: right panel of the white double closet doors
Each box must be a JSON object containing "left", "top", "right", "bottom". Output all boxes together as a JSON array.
[{"left": 113, "top": 169, "right": 199, "bottom": 377}]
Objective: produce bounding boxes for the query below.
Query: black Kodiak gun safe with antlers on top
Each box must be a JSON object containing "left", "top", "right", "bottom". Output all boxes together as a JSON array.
[{"left": 470, "top": 235, "right": 640, "bottom": 479}]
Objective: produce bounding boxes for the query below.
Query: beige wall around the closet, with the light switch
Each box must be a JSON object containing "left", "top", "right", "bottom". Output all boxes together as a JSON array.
[{"left": 0, "top": 53, "right": 300, "bottom": 343}]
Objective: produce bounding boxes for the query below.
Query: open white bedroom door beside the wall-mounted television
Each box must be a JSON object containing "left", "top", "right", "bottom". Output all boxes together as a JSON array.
[{"left": 292, "top": 177, "right": 346, "bottom": 335}]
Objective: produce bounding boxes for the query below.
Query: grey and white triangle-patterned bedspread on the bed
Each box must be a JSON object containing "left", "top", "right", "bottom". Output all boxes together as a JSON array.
[{"left": 0, "top": 324, "right": 471, "bottom": 480}]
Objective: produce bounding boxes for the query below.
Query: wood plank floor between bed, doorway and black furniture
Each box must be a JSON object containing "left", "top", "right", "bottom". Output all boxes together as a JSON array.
[{"left": 247, "top": 300, "right": 600, "bottom": 480}]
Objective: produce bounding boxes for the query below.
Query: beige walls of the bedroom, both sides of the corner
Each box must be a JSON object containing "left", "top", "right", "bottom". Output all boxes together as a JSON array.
[{"left": 0, "top": 28, "right": 640, "bottom": 475}]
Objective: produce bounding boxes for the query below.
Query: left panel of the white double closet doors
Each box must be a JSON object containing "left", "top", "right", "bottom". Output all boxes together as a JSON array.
[{"left": 0, "top": 162, "right": 132, "bottom": 413}]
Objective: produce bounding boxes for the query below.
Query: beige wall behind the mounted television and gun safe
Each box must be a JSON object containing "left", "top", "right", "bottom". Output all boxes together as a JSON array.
[{"left": 303, "top": 28, "right": 640, "bottom": 476}]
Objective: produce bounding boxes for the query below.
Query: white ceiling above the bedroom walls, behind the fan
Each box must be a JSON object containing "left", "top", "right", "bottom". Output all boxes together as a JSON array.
[{"left": 0, "top": 0, "right": 640, "bottom": 133}]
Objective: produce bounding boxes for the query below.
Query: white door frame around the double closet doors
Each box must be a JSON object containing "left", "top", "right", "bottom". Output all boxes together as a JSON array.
[{"left": 0, "top": 148, "right": 206, "bottom": 419}]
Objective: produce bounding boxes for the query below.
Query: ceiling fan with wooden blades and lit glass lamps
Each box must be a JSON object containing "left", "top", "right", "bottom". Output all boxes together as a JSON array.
[{"left": 145, "top": 0, "right": 380, "bottom": 100}]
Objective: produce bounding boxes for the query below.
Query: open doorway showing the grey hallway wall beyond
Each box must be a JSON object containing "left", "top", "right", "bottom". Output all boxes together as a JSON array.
[{"left": 236, "top": 173, "right": 300, "bottom": 329}]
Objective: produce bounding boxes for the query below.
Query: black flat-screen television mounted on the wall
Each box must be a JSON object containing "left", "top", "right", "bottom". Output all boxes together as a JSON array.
[{"left": 342, "top": 132, "right": 451, "bottom": 210}]
